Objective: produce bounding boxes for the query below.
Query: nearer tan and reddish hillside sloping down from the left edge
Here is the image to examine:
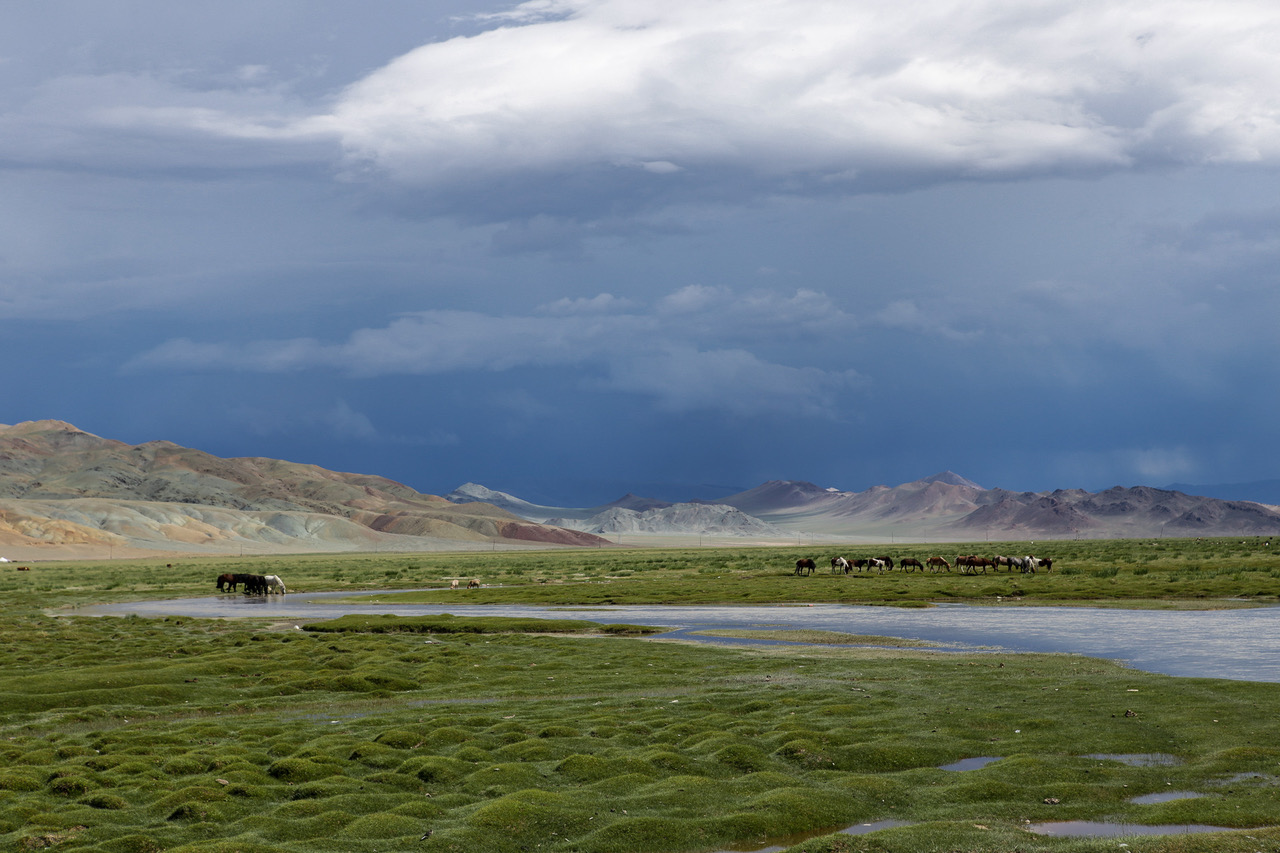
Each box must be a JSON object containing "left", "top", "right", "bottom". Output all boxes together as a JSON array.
[{"left": 0, "top": 420, "right": 607, "bottom": 551}]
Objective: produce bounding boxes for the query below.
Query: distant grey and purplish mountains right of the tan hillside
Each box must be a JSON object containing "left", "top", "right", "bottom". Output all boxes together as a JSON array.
[{"left": 444, "top": 471, "right": 1280, "bottom": 540}]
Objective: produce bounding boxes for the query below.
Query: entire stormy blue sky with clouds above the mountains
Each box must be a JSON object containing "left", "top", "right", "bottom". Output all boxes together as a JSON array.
[{"left": 0, "top": 0, "right": 1280, "bottom": 506}]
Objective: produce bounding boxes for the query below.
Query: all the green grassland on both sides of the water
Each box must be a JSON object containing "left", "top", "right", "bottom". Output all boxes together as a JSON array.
[{"left": 0, "top": 539, "right": 1280, "bottom": 853}]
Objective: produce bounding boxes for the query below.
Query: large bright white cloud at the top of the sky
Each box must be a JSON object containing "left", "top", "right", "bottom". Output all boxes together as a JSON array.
[{"left": 294, "top": 0, "right": 1280, "bottom": 204}]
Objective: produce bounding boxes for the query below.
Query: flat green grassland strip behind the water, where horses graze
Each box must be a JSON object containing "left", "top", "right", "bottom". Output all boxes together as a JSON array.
[{"left": 10, "top": 537, "right": 1280, "bottom": 607}]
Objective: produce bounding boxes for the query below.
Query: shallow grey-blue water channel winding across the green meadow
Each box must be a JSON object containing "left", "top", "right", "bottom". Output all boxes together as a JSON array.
[{"left": 76, "top": 589, "right": 1280, "bottom": 681}]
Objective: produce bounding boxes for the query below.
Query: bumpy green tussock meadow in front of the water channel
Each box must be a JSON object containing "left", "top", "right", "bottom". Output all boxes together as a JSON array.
[{"left": 0, "top": 607, "right": 1280, "bottom": 853}]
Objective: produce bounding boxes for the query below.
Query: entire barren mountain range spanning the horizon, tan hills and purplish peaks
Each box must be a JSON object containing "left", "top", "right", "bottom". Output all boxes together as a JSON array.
[{"left": 0, "top": 420, "right": 1280, "bottom": 560}]
